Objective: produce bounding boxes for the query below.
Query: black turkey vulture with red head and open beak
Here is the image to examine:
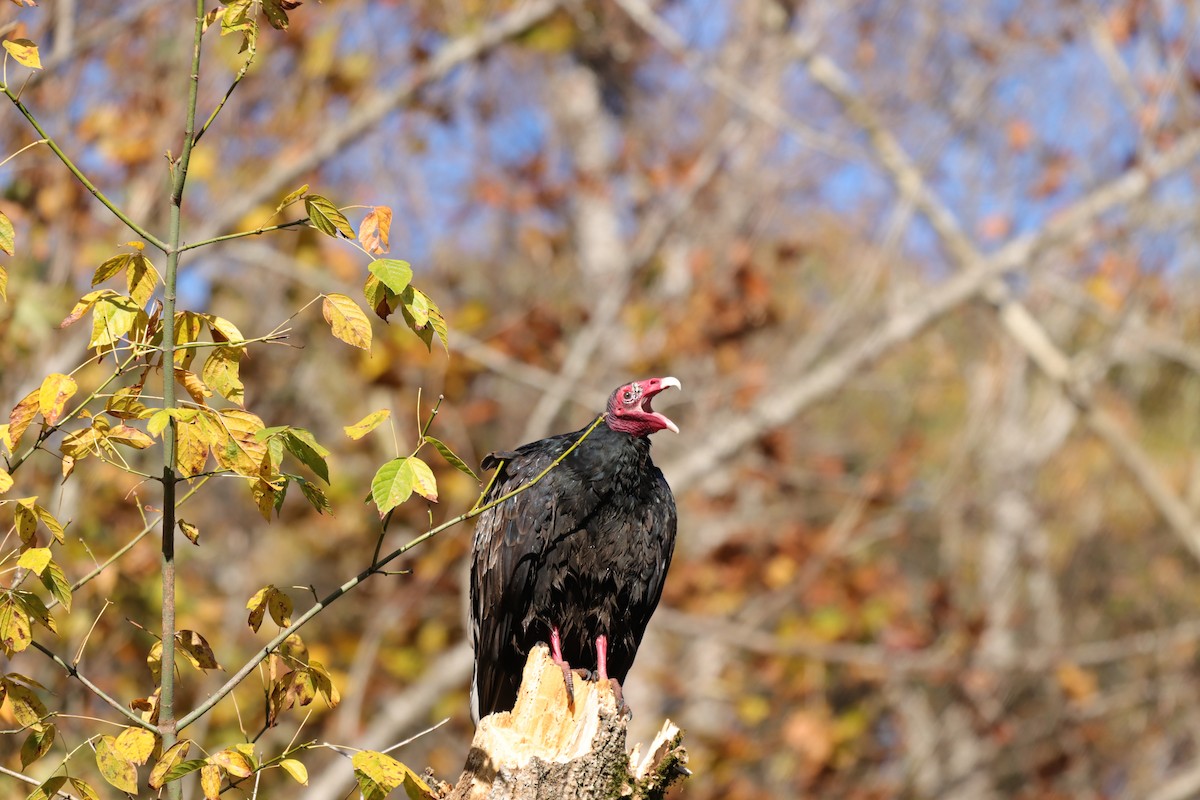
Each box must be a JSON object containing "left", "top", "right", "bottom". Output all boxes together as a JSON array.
[{"left": 470, "top": 378, "right": 679, "bottom": 721}]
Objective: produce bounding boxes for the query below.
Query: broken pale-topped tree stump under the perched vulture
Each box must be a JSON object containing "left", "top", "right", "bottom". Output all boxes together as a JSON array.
[{"left": 446, "top": 646, "right": 689, "bottom": 800}]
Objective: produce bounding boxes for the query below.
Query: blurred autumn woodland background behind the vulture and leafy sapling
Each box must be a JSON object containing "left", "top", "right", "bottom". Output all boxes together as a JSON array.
[{"left": 0, "top": 0, "right": 1200, "bottom": 800}]
